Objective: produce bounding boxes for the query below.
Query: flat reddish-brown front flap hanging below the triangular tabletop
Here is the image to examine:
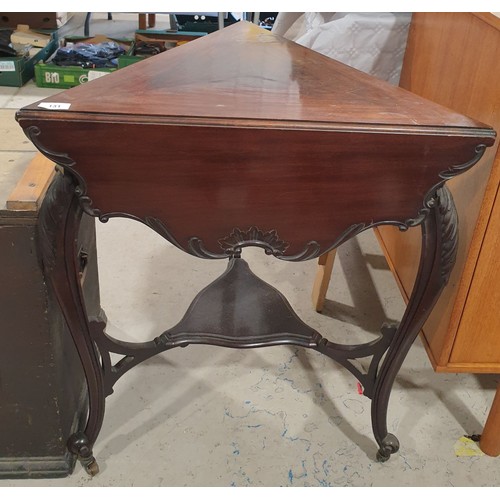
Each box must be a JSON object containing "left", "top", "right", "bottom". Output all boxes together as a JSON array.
[{"left": 16, "top": 120, "right": 492, "bottom": 255}]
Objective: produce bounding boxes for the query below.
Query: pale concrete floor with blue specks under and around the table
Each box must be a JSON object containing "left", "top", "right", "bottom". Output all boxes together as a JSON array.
[{"left": 0, "top": 12, "right": 500, "bottom": 488}]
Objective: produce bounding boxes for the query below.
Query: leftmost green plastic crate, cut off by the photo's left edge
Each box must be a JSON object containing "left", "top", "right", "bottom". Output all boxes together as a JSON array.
[{"left": 0, "top": 33, "right": 57, "bottom": 87}]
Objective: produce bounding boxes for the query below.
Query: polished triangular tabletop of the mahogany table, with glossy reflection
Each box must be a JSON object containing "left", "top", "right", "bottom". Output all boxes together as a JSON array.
[{"left": 18, "top": 22, "right": 492, "bottom": 133}]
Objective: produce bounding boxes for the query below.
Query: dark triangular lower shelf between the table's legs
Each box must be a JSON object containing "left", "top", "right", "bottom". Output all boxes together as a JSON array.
[{"left": 160, "top": 258, "right": 321, "bottom": 348}]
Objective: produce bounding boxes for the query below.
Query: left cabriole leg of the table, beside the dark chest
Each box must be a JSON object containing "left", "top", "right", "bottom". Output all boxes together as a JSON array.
[{"left": 39, "top": 174, "right": 104, "bottom": 475}]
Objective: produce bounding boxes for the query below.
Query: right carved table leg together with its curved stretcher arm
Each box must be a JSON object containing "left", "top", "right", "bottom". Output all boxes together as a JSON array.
[{"left": 317, "top": 187, "right": 458, "bottom": 462}]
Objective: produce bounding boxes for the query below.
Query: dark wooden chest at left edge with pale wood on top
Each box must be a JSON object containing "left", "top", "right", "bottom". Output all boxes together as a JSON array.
[{"left": 0, "top": 153, "right": 99, "bottom": 479}]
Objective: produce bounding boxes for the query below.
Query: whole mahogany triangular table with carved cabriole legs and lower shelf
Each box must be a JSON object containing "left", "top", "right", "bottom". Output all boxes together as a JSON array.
[{"left": 17, "top": 22, "right": 495, "bottom": 473}]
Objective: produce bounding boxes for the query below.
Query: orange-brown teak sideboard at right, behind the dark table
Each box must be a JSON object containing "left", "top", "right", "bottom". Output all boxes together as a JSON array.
[{"left": 376, "top": 13, "right": 500, "bottom": 455}]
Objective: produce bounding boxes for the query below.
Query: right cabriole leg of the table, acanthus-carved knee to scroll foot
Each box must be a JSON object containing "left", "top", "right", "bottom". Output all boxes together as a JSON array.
[{"left": 372, "top": 187, "right": 458, "bottom": 462}]
